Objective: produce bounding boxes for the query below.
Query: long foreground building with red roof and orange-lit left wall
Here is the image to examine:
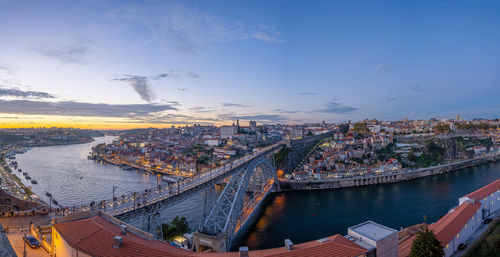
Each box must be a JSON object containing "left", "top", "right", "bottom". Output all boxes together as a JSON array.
[{"left": 47, "top": 212, "right": 367, "bottom": 257}]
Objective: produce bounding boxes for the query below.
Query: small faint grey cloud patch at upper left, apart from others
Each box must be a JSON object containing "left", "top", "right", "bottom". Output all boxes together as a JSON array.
[{"left": 35, "top": 41, "right": 90, "bottom": 64}]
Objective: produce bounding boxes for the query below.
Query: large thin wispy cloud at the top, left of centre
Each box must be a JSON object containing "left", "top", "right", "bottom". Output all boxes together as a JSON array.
[{"left": 113, "top": 1, "right": 282, "bottom": 54}]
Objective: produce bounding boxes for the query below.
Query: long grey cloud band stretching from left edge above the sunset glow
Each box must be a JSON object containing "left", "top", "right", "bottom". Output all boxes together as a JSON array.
[{"left": 0, "top": 100, "right": 177, "bottom": 118}]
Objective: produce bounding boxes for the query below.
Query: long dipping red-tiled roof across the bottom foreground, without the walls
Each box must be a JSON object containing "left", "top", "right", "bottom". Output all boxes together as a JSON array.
[{"left": 54, "top": 216, "right": 367, "bottom": 257}]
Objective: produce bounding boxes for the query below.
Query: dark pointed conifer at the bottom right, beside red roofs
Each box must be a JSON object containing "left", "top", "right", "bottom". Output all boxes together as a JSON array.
[{"left": 410, "top": 225, "right": 444, "bottom": 257}]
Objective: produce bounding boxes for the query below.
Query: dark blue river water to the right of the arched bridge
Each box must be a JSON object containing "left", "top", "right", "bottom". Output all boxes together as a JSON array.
[{"left": 235, "top": 162, "right": 500, "bottom": 249}]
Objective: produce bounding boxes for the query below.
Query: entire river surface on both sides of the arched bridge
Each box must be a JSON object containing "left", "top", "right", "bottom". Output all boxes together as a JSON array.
[{"left": 15, "top": 137, "right": 500, "bottom": 249}]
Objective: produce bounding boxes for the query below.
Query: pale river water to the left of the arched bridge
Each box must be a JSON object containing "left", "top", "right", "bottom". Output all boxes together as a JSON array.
[{"left": 14, "top": 136, "right": 202, "bottom": 229}]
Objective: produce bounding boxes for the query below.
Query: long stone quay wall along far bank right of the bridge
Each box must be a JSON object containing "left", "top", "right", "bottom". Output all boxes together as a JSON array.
[{"left": 279, "top": 155, "right": 500, "bottom": 191}]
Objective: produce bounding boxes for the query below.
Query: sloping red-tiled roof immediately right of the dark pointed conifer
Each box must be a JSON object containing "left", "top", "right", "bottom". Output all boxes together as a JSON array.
[{"left": 429, "top": 201, "right": 481, "bottom": 246}]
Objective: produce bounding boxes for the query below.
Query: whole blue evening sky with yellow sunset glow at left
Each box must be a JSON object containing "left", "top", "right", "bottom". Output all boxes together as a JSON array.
[{"left": 0, "top": 0, "right": 500, "bottom": 128}]
